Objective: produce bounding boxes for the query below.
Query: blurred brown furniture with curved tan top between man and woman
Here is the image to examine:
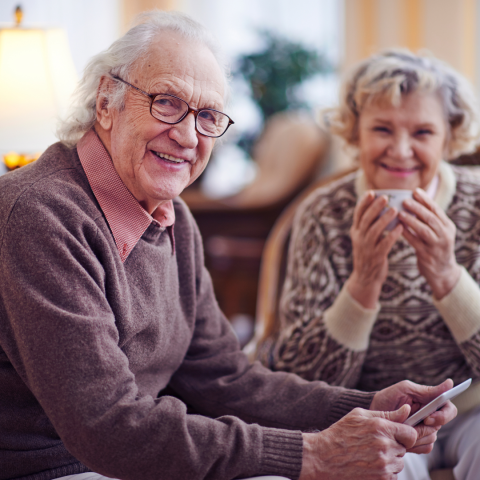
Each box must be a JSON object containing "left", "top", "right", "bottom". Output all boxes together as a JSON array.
[{"left": 182, "top": 113, "right": 329, "bottom": 322}]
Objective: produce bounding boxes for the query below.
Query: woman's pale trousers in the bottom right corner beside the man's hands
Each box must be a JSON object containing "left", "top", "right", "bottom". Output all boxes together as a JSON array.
[{"left": 397, "top": 407, "right": 480, "bottom": 480}]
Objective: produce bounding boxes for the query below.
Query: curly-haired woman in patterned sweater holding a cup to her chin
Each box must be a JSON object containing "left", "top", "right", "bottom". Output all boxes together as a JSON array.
[{"left": 261, "top": 50, "right": 480, "bottom": 480}]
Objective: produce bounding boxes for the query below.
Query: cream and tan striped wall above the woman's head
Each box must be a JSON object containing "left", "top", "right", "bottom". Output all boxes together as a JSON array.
[{"left": 344, "top": 0, "right": 480, "bottom": 82}]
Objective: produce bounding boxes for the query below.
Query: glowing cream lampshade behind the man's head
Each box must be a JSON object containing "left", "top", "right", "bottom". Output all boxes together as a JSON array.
[{"left": 0, "top": 27, "right": 77, "bottom": 154}]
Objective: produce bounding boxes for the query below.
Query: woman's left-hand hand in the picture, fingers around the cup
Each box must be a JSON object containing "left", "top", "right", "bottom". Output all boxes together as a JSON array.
[{"left": 347, "top": 191, "right": 403, "bottom": 308}]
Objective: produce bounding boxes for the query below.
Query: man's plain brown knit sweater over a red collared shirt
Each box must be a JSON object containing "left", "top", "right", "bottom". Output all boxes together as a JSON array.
[{"left": 0, "top": 144, "right": 373, "bottom": 480}]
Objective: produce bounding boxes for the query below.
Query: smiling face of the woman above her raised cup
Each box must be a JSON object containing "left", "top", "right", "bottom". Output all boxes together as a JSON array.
[{"left": 357, "top": 92, "right": 448, "bottom": 190}]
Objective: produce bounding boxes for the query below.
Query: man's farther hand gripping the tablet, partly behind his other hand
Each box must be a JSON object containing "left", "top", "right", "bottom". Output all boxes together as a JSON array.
[{"left": 370, "top": 379, "right": 457, "bottom": 453}]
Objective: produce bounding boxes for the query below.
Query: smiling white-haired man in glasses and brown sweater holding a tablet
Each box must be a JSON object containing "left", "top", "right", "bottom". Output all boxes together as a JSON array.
[{"left": 0, "top": 12, "right": 455, "bottom": 480}]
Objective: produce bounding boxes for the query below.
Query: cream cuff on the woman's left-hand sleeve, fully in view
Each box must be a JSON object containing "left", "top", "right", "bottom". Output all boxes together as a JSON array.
[{"left": 323, "top": 285, "right": 380, "bottom": 352}]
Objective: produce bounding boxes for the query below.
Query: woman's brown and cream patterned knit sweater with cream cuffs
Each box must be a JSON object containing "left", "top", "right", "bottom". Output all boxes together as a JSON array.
[{"left": 261, "top": 162, "right": 480, "bottom": 406}]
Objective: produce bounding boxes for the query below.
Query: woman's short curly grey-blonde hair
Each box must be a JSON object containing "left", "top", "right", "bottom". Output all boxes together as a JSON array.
[{"left": 326, "top": 49, "right": 480, "bottom": 160}]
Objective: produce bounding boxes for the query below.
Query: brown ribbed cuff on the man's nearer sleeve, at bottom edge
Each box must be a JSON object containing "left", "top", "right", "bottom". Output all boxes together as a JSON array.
[{"left": 260, "top": 428, "right": 303, "bottom": 480}]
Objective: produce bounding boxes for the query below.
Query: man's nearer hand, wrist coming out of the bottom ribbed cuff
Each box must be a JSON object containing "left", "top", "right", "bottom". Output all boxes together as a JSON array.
[{"left": 299, "top": 405, "right": 417, "bottom": 480}]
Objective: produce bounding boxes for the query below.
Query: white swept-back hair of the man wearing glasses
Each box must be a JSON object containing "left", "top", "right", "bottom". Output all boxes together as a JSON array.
[{"left": 57, "top": 10, "right": 228, "bottom": 147}]
